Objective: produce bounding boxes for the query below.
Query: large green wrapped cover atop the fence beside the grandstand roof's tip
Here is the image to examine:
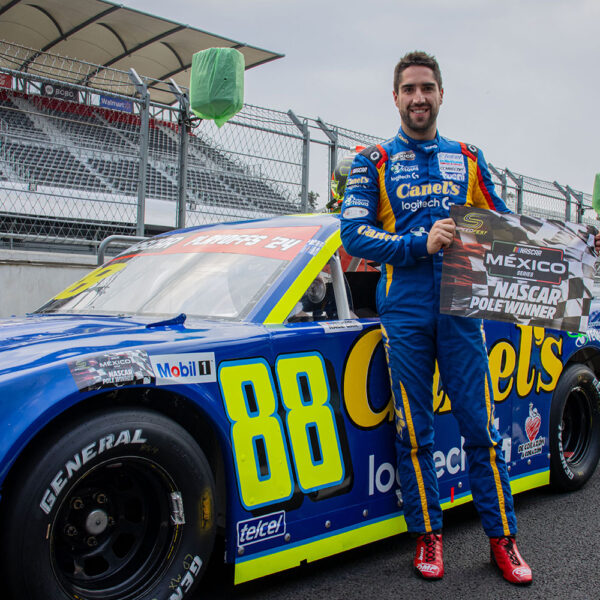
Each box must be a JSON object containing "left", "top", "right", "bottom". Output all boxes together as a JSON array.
[{"left": 190, "top": 48, "right": 245, "bottom": 127}]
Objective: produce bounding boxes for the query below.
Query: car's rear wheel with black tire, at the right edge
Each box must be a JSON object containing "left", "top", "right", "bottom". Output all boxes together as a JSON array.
[{"left": 550, "top": 364, "right": 600, "bottom": 491}]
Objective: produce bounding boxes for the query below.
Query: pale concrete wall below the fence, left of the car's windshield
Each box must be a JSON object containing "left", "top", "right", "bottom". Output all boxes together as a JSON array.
[{"left": 0, "top": 250, "right": 96, "bottom": 318}]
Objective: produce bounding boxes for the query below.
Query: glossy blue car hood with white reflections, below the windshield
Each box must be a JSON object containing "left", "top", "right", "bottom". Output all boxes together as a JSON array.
[{"left": 0, "top": 314, "right": 268, "bottom": 377}]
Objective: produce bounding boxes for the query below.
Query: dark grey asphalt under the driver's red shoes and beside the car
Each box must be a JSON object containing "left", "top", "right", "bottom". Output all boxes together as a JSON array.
[{"left": 199, "top": 468, "right": 600, "bottom": 600}]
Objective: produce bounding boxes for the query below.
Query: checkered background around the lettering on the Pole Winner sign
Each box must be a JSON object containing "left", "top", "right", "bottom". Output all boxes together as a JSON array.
[{"left": 441, "top": 205, "right": 597, "bottom": 332}]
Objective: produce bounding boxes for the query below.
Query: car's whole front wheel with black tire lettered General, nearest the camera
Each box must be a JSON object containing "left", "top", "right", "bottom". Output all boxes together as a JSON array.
[{"left": 0, "top": 409, "right": 216, "bottom": 600}]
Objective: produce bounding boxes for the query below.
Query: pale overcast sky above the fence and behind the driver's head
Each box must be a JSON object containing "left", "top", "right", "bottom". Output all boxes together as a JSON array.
[{"left": 121, "top": 0, "right": 600, "bottom": 202}]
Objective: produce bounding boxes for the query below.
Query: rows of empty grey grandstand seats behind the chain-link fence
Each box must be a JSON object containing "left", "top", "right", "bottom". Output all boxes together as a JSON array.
[{"left": 0, "top": 90, "right": 296, "bottom": 214}]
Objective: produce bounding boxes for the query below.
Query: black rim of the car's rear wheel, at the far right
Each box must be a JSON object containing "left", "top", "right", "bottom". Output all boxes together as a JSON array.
[{"left": 561, "top": 387, "right": 592, "bottom": 465}]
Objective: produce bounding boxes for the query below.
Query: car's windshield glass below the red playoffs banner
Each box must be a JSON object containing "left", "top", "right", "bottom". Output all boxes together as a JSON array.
[{"left": 38, "top": 252, "right": 286, "bottom": 320}]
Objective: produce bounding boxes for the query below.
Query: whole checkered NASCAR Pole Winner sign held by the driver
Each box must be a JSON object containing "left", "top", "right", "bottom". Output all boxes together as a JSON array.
[{"left": 440, "top": 205, "right": 597, "bottom": 331}]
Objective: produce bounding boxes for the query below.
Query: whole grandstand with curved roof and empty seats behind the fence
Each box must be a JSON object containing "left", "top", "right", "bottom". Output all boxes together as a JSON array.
[{"left": 0, "top": 0, "right": 298, "bottom": 249}]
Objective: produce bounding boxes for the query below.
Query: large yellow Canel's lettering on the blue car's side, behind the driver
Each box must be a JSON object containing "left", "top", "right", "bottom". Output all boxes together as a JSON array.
[{"left": 343, "top": 325, "right": 563, "bottom": 429}]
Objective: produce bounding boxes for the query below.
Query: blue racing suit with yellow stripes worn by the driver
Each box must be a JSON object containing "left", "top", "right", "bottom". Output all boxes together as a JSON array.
[{"left": 341, "top": 129, "right": 517, "bottom": 537}]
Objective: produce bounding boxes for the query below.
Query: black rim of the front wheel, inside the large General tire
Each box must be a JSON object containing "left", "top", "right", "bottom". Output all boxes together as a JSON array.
[{"left": 51, "top": 457, "right": 178, "bottom": 600}]
